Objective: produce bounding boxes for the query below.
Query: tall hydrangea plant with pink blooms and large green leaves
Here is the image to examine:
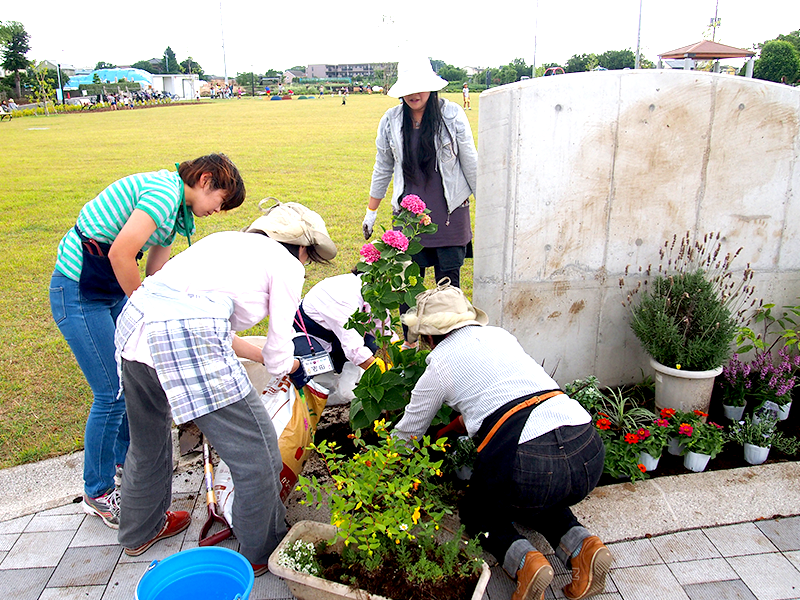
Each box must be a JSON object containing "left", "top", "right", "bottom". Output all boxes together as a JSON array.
[{"left": 346, "top": 194, "right": 444, "bottom": 429}]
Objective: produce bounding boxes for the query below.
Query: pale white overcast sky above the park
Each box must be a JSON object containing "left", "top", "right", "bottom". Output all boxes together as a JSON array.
[{"left": 6, "top": 0, "right": 800, "bottom": 77}]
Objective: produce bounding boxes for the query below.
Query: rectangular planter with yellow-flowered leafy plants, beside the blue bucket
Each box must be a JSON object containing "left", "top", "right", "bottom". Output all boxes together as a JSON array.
[{"left": 269, "top": 421, "right": 490, "bottom": 600}]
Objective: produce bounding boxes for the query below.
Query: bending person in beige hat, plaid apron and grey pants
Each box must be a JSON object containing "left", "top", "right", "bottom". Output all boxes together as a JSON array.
[{"left": 115, "top": 202, "right": 336, "bottom": 575}]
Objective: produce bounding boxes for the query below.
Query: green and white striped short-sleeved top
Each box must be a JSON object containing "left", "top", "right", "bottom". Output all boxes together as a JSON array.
[{"left": 56, "top": 169, "right": 194, "bottom": 281}]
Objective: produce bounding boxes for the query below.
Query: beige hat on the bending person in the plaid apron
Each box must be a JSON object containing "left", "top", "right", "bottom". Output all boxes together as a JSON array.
[{"left": 245, "top": 198, "right": 336, "bottom": 260}]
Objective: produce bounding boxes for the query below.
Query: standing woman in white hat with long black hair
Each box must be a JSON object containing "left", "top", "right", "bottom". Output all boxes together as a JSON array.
[{"left": 362, "top": 56, "right": 478, "bottom": 296}]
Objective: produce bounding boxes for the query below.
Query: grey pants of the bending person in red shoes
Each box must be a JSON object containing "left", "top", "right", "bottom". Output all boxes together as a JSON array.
[{"left": 118, "top": 360, "right": 286, "bottom": 565}]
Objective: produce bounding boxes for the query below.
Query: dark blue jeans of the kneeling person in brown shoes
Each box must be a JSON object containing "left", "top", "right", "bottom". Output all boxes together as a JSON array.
[{"left": 460, "top": 423, "right": 605, "bottom": 563}]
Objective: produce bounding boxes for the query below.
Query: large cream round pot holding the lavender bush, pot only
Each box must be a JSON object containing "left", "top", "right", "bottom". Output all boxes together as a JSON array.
[{"left": 650, "top": 358, "right": 722, "bottom": 413}]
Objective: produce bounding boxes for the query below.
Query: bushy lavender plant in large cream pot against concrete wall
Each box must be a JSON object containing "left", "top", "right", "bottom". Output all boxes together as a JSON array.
[{"left": 621, "top": 232, "right": 753, "bottom": 412}]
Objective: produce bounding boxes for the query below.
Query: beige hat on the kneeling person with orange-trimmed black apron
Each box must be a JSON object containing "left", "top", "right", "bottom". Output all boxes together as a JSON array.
[{"left": 402, "top": 277, "right": 489, "bottom": 343}]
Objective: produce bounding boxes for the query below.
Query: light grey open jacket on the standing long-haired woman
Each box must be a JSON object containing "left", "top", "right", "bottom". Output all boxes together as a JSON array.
[{"left": 369, "top": 99, "right": 478, "bottom": 212}]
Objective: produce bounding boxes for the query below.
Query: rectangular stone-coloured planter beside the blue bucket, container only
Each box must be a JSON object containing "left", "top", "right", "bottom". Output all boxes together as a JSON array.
[{"left": 269, "top": 521, "right": 491, "bottom": 600}]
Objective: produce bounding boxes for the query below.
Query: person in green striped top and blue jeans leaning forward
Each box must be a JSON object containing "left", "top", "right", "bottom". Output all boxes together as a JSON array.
[{"left": 50, "top": 154, "right": 245, "bottom": 529}]
